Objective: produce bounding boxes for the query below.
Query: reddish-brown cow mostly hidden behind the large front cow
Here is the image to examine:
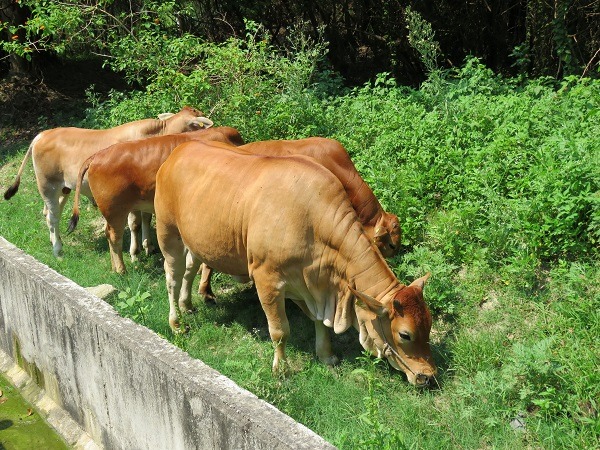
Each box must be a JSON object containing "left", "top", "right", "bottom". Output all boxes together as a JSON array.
[{"left": 198, "top": 137, "right": 401, "bottom": 302}]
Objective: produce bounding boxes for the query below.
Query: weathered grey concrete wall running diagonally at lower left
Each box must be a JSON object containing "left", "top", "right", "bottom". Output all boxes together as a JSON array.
[{"left": 0, "top": 237, "right": 333, "bottom": 450}]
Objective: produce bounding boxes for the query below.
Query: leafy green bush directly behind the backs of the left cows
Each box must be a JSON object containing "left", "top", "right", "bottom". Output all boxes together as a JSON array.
[{"left": 83, "top": 22, "right": 331, "bottom": 140}]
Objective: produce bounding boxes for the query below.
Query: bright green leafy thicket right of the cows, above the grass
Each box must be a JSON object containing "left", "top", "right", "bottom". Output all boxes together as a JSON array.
[{"left": 334, "top": 60, "right": 600, "bottom": 268}]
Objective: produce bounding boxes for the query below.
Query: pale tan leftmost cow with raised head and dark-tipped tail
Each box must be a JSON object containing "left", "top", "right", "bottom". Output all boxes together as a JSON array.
[{"left": 4, "top": 106, "right": 212, "bottom": 257}]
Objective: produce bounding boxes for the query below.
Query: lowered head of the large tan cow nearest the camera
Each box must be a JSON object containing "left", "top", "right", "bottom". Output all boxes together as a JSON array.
[{"left": 351, "top": 273, "right": 437, "bottom": 386}]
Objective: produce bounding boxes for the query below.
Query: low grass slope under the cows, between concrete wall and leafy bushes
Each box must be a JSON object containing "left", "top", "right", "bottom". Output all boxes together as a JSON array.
[{"left": 0, "top": 75, "right": 600, "bottom": 448}]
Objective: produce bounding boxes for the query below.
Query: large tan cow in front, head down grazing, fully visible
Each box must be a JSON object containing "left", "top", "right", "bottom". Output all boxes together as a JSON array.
[{"left": 154, "top": 141, "right": 436, "bottom": 385}]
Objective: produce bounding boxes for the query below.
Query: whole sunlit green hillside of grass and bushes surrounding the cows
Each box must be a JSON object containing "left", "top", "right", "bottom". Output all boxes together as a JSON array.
[{"left": 0, "top": 4, "right": 600, "bottom": 449}]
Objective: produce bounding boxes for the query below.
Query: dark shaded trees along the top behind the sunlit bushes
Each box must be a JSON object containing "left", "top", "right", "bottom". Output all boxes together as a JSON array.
[{"left": 0, "top": 0, "right": 600, "bottom": 85}]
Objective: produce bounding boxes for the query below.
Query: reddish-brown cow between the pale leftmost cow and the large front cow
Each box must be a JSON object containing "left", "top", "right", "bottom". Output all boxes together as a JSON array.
[{"left": 69, "top": 127, "right": 244, "bottom": 273}]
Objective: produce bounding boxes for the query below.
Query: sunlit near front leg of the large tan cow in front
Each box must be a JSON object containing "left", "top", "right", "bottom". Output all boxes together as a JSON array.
[{"left": 252, "top": 267, "right": 290, "bottom": 373}]
